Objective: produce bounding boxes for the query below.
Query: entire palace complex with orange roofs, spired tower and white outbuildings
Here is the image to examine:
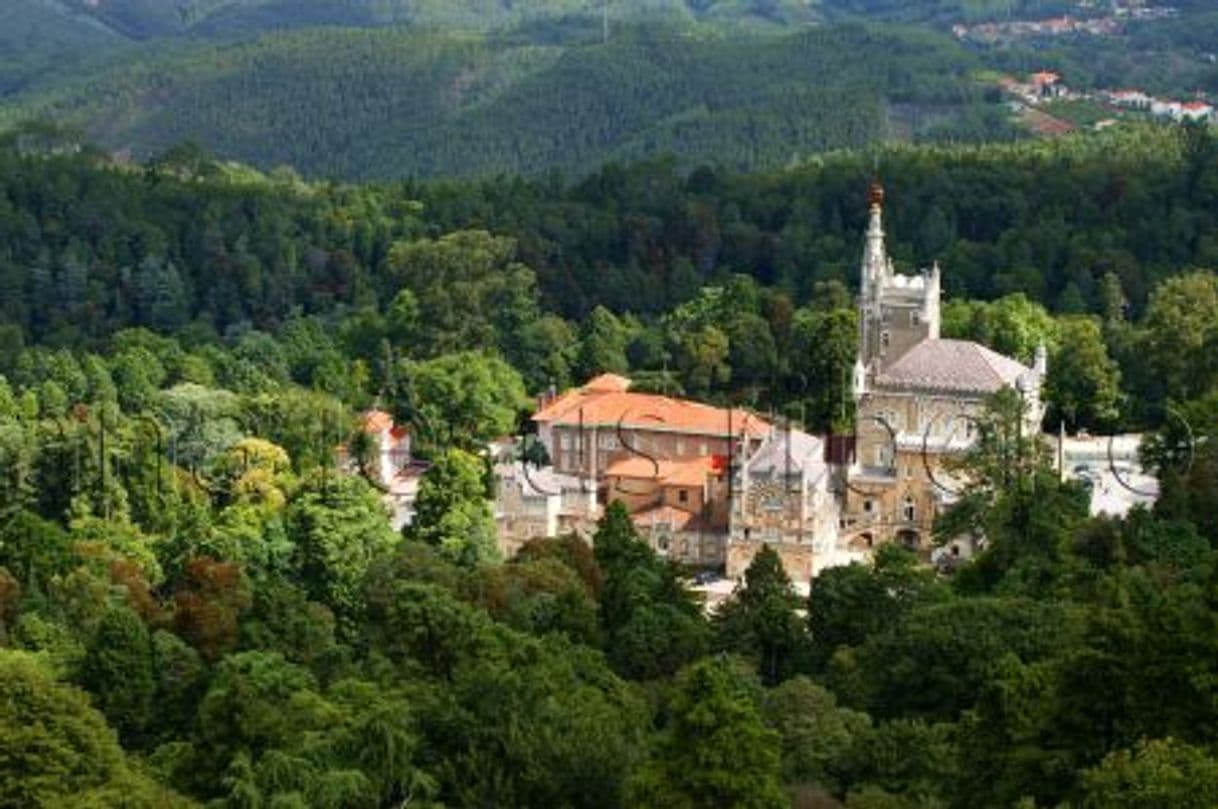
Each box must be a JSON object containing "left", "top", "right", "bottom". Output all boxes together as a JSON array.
[{"left": 345, "top": 185, "right": 1157, "bottom": 603}]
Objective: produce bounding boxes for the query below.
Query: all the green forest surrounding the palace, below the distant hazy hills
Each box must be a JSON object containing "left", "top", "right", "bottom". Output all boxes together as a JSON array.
[{"left": 7, "top": 121, "right": 1218, "bottom": 809}]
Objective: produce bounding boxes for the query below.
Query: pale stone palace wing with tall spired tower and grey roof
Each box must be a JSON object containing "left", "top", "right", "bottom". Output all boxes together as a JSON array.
[{"left": 842, "top": 184, "right": 1046, "bottom": 549}]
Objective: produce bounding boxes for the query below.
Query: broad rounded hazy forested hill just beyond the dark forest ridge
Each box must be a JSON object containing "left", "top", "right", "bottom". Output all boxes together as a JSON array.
[{"left": 5, "top": 24, "right": 1011, "bottom": 179}]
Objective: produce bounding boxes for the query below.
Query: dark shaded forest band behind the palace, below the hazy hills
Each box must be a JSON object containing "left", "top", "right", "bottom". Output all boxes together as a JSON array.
[{"left": 0, "top": 121, "right": 1198, "bottom": 341}]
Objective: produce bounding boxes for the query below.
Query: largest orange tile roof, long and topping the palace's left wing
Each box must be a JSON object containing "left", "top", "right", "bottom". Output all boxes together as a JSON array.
[{"left": 533, "top": 376, "right": 770, "bottom": 437}]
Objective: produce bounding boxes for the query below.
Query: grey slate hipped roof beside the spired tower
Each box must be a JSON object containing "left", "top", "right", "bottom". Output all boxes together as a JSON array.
[{"left": 876, "top": 340, "right": 1030, "bottom": 394}]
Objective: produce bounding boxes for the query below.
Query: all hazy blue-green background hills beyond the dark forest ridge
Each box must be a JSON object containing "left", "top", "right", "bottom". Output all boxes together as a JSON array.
[{"left": 0, "top": 0, "right": 1218, "bottom": 182}]
